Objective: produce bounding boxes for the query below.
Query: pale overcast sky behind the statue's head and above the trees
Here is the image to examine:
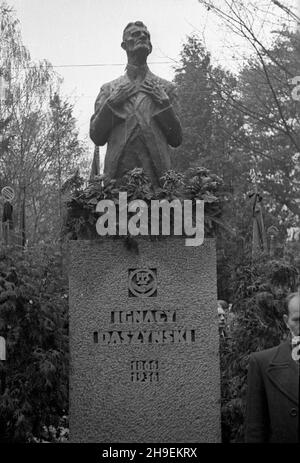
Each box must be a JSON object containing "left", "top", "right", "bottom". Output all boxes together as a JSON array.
[{"left": 7, "top": 0, "right": 300, "bottom": 160}]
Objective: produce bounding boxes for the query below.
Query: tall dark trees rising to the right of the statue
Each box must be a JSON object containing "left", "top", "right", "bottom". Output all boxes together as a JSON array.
[{"left": 173, "top": 29, "right": 300, "bottom": 301}]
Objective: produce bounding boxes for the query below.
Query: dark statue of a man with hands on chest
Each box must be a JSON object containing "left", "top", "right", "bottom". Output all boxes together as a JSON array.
[{"left": 90, "top": 21, "right": 182, "bottom": 186}]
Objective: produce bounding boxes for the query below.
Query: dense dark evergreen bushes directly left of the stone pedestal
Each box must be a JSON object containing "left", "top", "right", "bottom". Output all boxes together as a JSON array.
[{"left": 0, "top": 243, "right": 68, "bottom": 442}]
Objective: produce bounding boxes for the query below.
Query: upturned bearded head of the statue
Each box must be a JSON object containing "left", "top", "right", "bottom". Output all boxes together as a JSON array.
[{"left": 121, "top": 21, "right": 152, "bottom": 60}]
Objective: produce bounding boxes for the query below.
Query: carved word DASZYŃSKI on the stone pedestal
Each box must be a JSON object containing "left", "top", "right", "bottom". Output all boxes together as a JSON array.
[{"left": 94, "top": 328, "right": 195, "bottom": 345}]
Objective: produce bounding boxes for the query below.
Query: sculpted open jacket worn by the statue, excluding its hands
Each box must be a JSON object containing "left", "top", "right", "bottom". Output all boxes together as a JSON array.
[{"left": 90, "top": 67, "right": 182, "bottom": 183}]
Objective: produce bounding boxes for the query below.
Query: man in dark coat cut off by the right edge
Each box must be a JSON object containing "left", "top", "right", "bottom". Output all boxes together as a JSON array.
[{"left": 245, "top": 292, "right": 300, "bottom": 443}]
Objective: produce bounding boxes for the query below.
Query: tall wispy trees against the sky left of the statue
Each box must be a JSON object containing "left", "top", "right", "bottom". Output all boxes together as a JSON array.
[{"left": 0, "top": 3, "right": 86, "bottom": 245}]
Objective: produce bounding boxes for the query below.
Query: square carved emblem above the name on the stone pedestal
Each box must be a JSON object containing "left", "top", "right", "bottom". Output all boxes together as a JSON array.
[{"left": 128, "top": 268, "right": 157, "bottom": 297}]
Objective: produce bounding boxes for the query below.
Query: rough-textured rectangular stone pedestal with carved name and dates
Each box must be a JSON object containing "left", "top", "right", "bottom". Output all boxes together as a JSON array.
[{"left": 70, "top": 237, "right": 221, "bottom": 443}]
